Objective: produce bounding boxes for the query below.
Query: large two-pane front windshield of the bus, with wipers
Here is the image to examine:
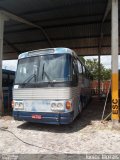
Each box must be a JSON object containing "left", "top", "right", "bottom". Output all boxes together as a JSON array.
[{"left": 15, "top": 54, "right": 71, "bottom": 84}]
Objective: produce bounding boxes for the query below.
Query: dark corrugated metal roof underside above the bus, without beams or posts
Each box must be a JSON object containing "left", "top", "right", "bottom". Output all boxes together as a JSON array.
[{"left": 0, "top": 0, "right": 117, "bottom": 57}]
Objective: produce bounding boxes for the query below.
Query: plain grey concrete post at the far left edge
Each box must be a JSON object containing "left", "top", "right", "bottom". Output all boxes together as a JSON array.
[{"left": 0, "top": 15, "right": 4, "bottom": 113}]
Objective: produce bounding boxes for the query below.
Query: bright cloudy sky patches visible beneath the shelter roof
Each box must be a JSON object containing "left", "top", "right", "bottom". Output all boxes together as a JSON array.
[{"left": 3, "top": 56, "right": 120, "bottom": 71}]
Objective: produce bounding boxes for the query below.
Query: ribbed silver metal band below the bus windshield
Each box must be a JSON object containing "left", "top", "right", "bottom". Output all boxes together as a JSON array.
[{"left": 13, "top": 87, "right": 79, "bottom": 99}]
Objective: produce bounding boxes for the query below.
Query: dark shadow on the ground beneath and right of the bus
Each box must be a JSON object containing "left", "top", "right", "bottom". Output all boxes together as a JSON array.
[{"left": 18, "top": 97, "right": 110, "bottom": 133}]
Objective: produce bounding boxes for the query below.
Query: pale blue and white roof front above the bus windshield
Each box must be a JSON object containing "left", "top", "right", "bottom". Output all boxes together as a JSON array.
[{"left": 18, "top": 47, "right": 77, "bottom": 59}]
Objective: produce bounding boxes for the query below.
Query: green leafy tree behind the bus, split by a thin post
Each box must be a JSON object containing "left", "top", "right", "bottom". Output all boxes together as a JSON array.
[{"left": 85, "top": 59, "right": 111, "bottom": 81}]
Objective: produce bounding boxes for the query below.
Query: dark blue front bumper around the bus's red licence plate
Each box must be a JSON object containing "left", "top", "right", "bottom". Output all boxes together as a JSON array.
[{"left": 13, "top": 111, "right": 74, "bottom": 124}]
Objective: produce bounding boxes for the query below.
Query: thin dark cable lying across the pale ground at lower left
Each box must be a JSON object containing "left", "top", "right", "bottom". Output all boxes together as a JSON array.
[{"left": 0, "top": 127, "right": 62, "bottom": 153}]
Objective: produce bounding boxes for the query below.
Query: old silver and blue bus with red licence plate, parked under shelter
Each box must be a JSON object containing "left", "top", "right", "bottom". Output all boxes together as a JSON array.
[{"left": 12, "top": 48, "right": 91, "bottom": 124}]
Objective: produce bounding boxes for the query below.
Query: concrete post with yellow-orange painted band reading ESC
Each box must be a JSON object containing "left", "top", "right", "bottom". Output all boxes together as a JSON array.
[{"left": 111, "top": 0, "right": 119, "bottom": 123}]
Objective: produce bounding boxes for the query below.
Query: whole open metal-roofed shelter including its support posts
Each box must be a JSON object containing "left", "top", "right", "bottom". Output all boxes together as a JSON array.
[{"left": 0, "top": 0, "right": 120, "bottom": 122}]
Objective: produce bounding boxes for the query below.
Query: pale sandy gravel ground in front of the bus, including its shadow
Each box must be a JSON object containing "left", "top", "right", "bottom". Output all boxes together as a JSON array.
[{"left": 0, "top": 98, "right": 120, "bottom": 154}]
